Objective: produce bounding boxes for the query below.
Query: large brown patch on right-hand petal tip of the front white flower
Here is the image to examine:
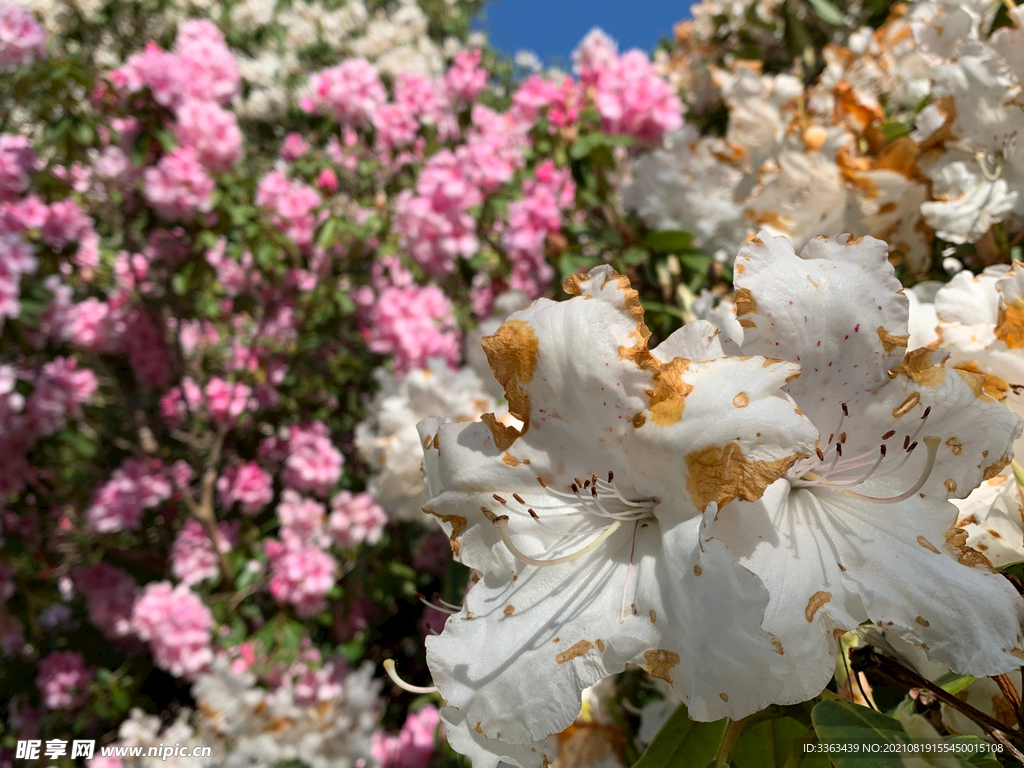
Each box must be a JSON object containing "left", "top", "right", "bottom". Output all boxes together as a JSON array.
[{"left": 686, "top": 442, "right": 799, "bottom": 509}]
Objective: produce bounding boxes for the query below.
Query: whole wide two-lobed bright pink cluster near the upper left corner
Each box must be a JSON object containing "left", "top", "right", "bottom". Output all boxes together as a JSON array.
[{"left": 110, "top": 18, "right": 242, "bottom": 109}]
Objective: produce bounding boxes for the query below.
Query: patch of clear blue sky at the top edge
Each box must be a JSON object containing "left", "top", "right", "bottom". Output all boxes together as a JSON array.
[{"left": 477, "top": 0, "right": 690, "bottom": 65}]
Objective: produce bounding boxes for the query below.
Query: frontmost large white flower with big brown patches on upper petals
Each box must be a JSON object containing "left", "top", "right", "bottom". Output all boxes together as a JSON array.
[{"left": 420, "top": 266, "right": 813, "bottom": 766}]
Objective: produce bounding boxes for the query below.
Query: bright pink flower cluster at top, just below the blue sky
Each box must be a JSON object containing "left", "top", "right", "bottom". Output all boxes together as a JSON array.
[{"left": 573, "top": 30, "right": 683, "bottom": 144}]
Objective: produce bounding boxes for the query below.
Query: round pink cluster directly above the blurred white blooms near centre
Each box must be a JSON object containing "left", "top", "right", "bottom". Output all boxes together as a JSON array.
[{"left": 362, "top": 286, "right": 461, "bottom": 375}]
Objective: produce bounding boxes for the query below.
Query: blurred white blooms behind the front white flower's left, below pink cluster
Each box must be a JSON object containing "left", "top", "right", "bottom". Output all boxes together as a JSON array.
[{"left": 355, "top": 359, "right": 509, "bottom": 521}]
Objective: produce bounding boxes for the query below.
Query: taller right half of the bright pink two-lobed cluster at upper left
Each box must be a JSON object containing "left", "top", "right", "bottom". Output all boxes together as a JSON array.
[{"left": 174, "top": 18, "right": 242, "bottom": 104}]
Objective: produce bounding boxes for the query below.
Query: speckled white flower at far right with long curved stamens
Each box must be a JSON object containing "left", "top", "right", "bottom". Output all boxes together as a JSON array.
[{"left": 711, "top": 232, "right": 1024, "bottom": 703}]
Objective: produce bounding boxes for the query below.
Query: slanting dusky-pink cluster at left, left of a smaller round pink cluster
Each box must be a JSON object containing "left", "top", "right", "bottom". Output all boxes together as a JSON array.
[{"left": 85, "top": 459, "right": 171, "bottom": 534}]
